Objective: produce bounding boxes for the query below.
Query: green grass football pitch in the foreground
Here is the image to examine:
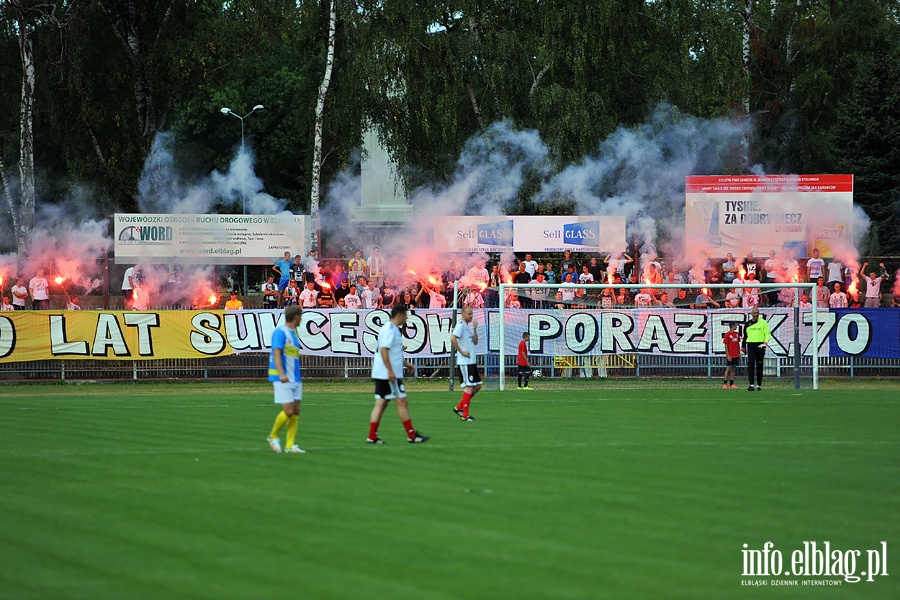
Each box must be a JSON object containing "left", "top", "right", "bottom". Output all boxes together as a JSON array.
[{"left": 0, "top": 382, "right": 900, "bottom": 600}]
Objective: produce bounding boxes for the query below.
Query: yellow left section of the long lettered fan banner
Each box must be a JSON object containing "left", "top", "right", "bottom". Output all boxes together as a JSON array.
[{"left": 0, "top": 310, "right": 234, "bottom": 362}]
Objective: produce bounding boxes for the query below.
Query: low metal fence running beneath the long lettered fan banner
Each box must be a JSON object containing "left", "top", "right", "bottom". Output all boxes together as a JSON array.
[{"left": 0, "top": 353, "right": 900, "bottom": 383}]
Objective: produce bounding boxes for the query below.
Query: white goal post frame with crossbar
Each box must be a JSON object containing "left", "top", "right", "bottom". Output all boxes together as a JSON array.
[{"left": 498, "top": 282, "right": 820, "bottom": 391}]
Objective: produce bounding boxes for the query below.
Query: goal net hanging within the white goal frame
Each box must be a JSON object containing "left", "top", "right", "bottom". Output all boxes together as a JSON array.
[{"left": 484, "top": 283, "right": 828, "bottom": 390}]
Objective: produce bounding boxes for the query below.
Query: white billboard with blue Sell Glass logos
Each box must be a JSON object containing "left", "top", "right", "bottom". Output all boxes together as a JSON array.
[{"left": 434, "top": 216, "right": 625, "bottom": 253}]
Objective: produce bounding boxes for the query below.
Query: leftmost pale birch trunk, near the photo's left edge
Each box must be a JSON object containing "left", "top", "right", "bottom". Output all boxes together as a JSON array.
[{"left": 10, "top": 0, "right": 35, "bottom": 254}]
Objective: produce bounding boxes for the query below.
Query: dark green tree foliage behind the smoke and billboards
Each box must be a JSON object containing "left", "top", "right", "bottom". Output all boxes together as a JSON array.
[{"left": 0, "top": 0, "right": 900, "bottom": 252}]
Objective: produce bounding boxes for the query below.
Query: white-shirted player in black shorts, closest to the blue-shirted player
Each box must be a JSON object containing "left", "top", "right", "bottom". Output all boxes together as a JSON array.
[{"left": 366, "top": 308, "right": 429, "bottom": 444}]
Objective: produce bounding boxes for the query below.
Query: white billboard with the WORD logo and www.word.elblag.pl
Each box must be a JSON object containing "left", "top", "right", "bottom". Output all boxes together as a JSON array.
[{"left": 114, "top": 213, "right": 309, "bottom": 265}]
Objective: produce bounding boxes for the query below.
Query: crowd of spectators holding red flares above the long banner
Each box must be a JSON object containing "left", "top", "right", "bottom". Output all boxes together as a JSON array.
[{"left": 8, "top": 246, "right": 900, "bottom": 310}]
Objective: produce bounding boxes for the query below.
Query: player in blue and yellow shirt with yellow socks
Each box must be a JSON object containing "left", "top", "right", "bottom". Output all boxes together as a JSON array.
[{"left": 266, "top": 305, "right": 305, "bottom": 454}]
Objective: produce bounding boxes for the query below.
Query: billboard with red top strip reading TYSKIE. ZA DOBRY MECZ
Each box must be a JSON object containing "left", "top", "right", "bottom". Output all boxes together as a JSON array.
[{"left": 685, "top": 175, "right": 853, "bottom": 258}]
